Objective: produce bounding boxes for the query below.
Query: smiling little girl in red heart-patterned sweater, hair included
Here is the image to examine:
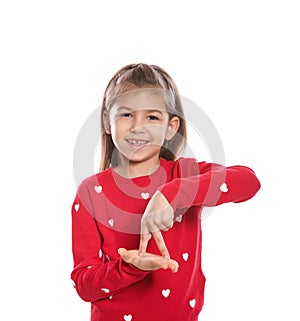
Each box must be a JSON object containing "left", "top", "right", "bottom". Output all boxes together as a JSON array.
[{"left": 71, "top": 64, "right": 260, "bottom": 321}]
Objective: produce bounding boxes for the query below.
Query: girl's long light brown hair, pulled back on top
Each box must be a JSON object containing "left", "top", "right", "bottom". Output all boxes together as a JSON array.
[{"left": 100, "top": 63, "right": 187, "bottom": 171}]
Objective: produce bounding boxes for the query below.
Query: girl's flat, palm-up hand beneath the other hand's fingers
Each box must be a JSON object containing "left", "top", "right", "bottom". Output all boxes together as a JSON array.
[{"left": 118, "top": 248, "right": 179, "bottom": 273}]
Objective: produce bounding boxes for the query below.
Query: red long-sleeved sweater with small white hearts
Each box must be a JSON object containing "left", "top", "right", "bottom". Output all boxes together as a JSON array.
[{"left": 71, "top": 158, "right": 260, "bottom": 321}]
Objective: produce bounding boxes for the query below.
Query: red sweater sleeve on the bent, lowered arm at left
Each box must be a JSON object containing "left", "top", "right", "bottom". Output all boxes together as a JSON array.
[{"left": 71, "top": 181, "right": 149, "bottom": 302}]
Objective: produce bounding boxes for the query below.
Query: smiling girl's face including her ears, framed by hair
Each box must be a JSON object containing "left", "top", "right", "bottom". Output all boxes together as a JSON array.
[{"left": 104, "top": 89, "right": 179, "bottom": 166}]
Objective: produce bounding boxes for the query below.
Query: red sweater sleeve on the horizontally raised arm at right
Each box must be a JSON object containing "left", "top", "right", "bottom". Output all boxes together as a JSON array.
[{"left": 159, "top": 159, "right": 260, "bottom": 211}]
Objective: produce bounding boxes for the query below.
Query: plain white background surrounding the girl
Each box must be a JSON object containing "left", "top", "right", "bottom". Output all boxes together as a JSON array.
[{"left": 0, "top": 0, "right": 300, "bottom": 321}]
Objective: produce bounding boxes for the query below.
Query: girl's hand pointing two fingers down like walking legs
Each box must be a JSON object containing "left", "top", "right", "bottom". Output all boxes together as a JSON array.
[{"left": 139, "top": 191, "right": 174, "bottom": 259}]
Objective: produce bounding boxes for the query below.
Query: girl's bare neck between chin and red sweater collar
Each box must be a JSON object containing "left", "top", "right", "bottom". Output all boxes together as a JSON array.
[{"left": 114, "top": 157, "right": 160, "bottom": 178}]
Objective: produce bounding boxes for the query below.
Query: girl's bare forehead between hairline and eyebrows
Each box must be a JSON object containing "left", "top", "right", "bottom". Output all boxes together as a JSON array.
[{"left": 112, "top": 88, "right": 167, "bottom": 111}]
